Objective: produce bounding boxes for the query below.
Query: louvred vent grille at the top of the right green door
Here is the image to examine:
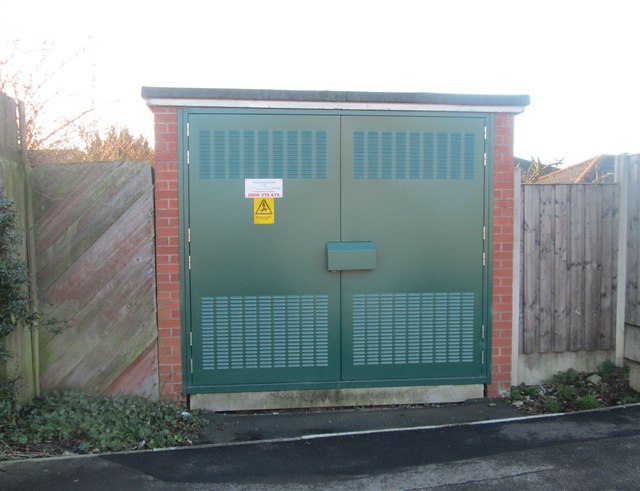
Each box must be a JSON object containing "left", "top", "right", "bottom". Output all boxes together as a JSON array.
[{"left": 353, "top": 131, "right": 476, "bottom": 180}]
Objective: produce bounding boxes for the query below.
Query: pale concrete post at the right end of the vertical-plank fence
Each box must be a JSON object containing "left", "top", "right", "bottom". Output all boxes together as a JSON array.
[{"left": 615, "top": 154, "right": 629, "bottom": 367}]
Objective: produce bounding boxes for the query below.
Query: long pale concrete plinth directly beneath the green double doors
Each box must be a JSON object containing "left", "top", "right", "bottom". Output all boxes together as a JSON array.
[{"left": 189, "top": 384, "right": 484, "bottom": 411}]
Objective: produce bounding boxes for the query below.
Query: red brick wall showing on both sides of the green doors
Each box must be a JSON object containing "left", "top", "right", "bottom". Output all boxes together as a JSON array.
[{"left": 152, "top": 107, "right": 514, "bottom": 399}]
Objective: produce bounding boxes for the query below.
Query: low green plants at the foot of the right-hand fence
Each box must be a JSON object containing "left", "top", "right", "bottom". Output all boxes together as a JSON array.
[{"left": 511, "top": 361, "right": 640, "bottom": 414}]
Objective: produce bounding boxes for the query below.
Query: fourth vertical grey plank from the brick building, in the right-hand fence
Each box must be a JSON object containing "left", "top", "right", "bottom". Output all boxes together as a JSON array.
[{"left": 569, "top": 185, "right": 585, "bottom": 351}]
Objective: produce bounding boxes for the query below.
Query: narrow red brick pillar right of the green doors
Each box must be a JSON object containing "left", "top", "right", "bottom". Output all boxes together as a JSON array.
[{"left": 487, "top": 114, "right": 514, "bottom": 397}]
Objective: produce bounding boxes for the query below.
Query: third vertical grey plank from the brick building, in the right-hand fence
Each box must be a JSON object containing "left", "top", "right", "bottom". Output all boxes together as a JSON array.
[{"left": 553, "top": 184, "right": 571, "bottom": 353}]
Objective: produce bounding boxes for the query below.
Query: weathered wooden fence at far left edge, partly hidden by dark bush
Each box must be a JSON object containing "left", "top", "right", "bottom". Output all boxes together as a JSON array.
[{"left": 0, "top": 92, "right": 39, "bottom": 401}]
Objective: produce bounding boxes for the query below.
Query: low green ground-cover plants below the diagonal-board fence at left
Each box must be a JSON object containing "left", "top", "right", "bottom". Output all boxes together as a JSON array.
[{"left": 0, "top": 390, "right": 206, "bottom": 460}]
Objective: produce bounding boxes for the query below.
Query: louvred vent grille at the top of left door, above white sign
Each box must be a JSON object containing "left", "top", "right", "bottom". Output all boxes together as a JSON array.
[{"left": 197, "top": 130, "right": 328, "bottom": 179}]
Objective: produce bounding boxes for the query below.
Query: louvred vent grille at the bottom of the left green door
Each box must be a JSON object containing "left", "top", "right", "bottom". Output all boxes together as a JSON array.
[{"left": 201, "top": 295, "right": 329, "bottom": 370}]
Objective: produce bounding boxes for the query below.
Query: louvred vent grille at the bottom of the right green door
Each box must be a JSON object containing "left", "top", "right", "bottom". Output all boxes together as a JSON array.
[{"left": 353, "top": 293, "right": 474, "bottom": 365}]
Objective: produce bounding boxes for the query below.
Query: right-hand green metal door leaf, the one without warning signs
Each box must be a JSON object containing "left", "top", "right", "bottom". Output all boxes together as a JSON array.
[{"left": 341, "top": 116, "right": 485, "bottom": 381}]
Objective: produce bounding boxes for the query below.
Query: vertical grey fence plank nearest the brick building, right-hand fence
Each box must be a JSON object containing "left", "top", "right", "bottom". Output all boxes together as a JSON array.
[{"left": 522, "top": 185, "right": 540, "bottom": 353}]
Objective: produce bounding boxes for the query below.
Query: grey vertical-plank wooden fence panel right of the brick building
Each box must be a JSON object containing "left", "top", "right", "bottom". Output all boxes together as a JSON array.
[{"left": 520, "top": 184, "right": 618, "bottom": 354}]
